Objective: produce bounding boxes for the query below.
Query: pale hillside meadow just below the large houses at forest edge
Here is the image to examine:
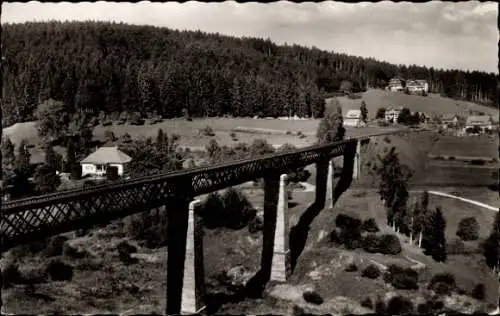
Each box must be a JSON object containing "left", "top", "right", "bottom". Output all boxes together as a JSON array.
[{"left": 327, "top": 90, "right": 499, "bottom": 119}]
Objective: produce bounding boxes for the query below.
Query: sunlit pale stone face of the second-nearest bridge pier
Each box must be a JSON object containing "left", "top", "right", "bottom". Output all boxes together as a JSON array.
[{"left": 271, "top": 174, "right": 291, "bottom": 282}]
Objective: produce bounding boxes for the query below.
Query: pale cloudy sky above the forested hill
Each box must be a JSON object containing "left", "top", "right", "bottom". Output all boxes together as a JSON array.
[{"left": 1, "top": 1, "right": 499, "bottom": 73}]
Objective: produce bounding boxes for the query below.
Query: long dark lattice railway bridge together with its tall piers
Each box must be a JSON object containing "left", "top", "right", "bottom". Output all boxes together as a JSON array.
[{"left": 0, "top": 129, "right": 425, "bottom": 314}]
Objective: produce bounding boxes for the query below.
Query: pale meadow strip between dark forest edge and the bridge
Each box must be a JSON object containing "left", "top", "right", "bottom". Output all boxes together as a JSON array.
[{"left": 4, "top": 118, "right": 393, "bottom": 163}]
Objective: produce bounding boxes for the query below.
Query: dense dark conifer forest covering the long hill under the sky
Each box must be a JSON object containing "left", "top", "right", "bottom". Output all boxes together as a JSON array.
[{"left": 1, "top": 21, "right": 497, "bottom": 126}]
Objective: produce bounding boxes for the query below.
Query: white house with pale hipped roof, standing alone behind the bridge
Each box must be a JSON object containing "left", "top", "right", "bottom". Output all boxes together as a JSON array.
[{"left": 80, "top": 146, "right": 132, "bottom": 177}]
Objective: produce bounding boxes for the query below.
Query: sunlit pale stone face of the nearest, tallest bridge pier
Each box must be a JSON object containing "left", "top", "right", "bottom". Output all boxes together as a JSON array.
[{"left": 181, "top": 200, "right": 205, "bottom": 315}]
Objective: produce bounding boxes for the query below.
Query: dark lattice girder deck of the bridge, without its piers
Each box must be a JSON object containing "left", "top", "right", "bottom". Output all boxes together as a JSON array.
[{"left": 0, "top": 131, "right": 428, "bottom": 251}]
